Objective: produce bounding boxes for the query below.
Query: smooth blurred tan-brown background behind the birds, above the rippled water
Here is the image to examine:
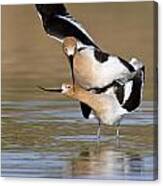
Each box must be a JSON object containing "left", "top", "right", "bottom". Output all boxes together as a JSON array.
[{"left": 1, "top": 2, "right": 156, "bottom": 100}]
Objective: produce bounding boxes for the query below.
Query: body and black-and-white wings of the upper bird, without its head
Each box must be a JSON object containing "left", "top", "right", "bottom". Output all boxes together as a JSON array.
[{"left": 36, "top": 4, "right": 144, "bottom": 118}]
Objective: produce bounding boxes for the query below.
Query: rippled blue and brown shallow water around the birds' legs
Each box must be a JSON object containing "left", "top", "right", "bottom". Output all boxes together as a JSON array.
[{"left": 2, "top": 101, "right": 156, "bottom": 180}]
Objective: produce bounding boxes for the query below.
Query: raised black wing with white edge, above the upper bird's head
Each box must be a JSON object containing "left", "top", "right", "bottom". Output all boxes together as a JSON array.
[{"left": 35, "top": 4, "right": 98, "bottom": 48}]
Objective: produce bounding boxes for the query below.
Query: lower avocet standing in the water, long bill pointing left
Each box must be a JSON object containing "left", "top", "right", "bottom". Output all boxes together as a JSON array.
[{"left": 38, "top": 59, "right": 144, "bottom": 138}]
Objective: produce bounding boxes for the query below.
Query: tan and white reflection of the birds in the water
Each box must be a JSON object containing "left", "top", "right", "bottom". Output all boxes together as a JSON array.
[{"left": 72, "top": 145, "right": 152, "bottom": 179}]
